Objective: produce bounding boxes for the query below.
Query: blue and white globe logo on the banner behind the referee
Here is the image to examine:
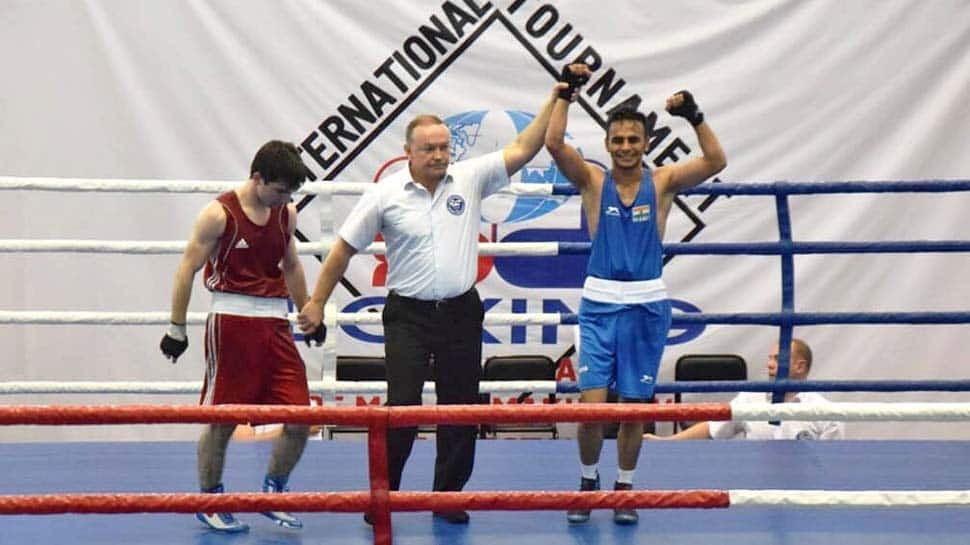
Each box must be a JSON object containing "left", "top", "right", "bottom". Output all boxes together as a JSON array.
[{"left": 444, "top": 110, "right": 582, "bottom": 223}]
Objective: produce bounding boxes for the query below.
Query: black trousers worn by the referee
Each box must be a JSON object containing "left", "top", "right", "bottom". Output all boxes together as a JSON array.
[{"left": 383, "top": 288, "right": 484, "bottom": 491}]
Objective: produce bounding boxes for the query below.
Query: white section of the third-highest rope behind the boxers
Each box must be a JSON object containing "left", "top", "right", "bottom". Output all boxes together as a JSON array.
[{"left": 0, "top": 310, "right": 562, "bottom": 326}]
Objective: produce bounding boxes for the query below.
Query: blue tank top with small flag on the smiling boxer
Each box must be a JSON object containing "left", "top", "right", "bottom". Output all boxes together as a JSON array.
[{"left": 586, "top": 170, "right": 663, "bottom": 281}]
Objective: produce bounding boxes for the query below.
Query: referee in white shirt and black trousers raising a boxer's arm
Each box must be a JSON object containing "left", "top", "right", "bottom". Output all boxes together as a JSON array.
[{"left": 298, "top": 83, "right": 572, "bottom": 524}]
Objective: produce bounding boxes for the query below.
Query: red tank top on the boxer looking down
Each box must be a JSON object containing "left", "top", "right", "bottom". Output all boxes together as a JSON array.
[{"left": 204, "top": 191, "right": 290, "bottom": 297}]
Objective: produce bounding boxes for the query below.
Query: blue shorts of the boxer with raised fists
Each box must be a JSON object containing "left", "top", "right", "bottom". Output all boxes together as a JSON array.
[{"left": 579, "top": 297, "right": 671, "bottom": 400}]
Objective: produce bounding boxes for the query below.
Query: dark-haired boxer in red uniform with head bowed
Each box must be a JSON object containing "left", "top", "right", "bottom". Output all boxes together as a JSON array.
[{"left": 161, "top": 140, "right": 326, "bottom": 532}]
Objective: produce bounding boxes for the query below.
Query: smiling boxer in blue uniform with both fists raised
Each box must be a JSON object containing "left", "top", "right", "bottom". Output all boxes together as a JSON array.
[{"left": 546, "top": 64, "right": 727, "bottom": 524}]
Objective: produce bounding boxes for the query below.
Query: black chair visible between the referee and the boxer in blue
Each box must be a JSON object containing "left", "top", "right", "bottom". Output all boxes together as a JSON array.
[{"left": 479, "top": 356, "right": 559, "bottom": 439}]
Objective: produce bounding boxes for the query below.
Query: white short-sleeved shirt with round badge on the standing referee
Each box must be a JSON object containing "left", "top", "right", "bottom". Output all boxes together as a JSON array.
[{"left": 339, "top": 150, "right": 509, "bottom": 300}]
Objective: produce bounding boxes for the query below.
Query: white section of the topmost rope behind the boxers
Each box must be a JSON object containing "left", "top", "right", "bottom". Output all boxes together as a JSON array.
[{"left": 0, "top": 176, "right": 553, "bottom": 196}]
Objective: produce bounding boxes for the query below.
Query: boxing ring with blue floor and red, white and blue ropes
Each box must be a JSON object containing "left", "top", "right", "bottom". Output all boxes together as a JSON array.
[{"left": 0, "top": 178, "right": 970, "bottom": 545}]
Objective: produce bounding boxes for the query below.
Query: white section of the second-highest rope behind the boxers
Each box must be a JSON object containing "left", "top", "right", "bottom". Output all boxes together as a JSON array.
[{"left": 0, "top": 239, "right": 559, "bottom": 256}]
